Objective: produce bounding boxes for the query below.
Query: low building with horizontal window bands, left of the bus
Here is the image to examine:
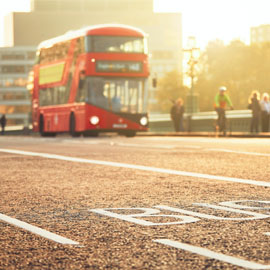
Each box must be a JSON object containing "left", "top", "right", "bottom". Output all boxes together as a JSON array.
[{"left": 0, "top": 47, "right": 36, "bottom": 126}]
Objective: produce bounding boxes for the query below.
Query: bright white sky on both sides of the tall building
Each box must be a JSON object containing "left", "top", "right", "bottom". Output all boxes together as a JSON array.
[{"left": 0, "top": 0, "right": 270, "bottom": 48}]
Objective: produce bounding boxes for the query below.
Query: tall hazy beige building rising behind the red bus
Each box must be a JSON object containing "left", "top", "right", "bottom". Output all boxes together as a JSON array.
[{"left": 5, "top": 0, "right": 182, "bottom": 111}]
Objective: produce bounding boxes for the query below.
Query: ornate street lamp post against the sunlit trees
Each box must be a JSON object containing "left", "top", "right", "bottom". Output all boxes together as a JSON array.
[{"left": 183, "top": 36, "right": 200, "bottom": 116}]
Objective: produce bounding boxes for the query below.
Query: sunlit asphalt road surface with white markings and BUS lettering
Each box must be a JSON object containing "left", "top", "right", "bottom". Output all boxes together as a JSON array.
[{"left": 0, "top": 135, "right": 270, "bottom": 270}]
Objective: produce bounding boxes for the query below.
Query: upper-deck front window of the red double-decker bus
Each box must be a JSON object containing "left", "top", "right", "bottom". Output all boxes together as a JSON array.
[{"left": 86, "top": 36, "right": 147, "bottom": 53}]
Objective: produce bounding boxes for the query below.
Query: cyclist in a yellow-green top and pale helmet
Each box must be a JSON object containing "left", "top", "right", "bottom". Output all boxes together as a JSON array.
[{"left": 215, "top": 86, "right": 233, "bottom": 135}]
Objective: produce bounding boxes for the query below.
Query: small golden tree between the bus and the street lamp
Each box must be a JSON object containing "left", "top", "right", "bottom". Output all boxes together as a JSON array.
[{"left": 157, "top": 70, "right": 188, "bottom": 113}]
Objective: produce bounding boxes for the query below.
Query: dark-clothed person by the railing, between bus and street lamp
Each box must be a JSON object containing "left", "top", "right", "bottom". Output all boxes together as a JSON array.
[{"left": 171, "top": 98, "right": 185, "bottom": 132}]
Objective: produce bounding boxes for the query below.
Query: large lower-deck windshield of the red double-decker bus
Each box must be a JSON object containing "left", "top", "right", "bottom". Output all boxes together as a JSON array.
[{"left": 76, "top": 77, "right": 146, "bottom": 113}]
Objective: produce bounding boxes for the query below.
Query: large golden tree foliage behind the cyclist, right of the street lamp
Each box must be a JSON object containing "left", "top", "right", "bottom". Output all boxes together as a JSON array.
[{"left": 195, "top": 40, "right": 270, "bottom": 111}]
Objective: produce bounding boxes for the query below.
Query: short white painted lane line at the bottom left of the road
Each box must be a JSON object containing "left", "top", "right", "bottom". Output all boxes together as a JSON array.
[{"left": 0, "top": 213, "right": 79, "bottom": 245}]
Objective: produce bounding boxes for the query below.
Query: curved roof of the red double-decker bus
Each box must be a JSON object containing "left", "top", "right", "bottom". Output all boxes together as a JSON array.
[{"left": 38, "top": 24, "right": 147, "bottom": 49}]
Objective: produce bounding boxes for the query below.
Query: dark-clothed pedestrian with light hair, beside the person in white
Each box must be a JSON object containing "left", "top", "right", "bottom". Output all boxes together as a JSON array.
[{"left": 248, "top": 90, "right": 261, "bottom": 133}]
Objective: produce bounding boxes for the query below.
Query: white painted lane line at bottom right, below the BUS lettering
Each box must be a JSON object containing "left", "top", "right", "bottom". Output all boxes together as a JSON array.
[{"left": 153, "top": 239, "right": 270, "bottom": 269}]
